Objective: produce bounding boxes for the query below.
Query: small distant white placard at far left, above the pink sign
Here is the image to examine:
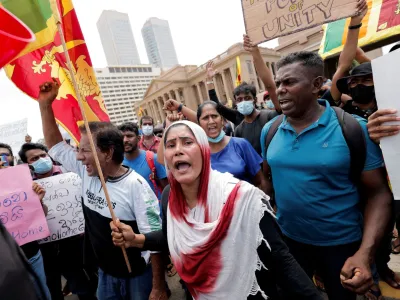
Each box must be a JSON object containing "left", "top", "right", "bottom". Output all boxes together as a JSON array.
[{"left": 0, "top": 119, "right": 28, "bottom": 155}]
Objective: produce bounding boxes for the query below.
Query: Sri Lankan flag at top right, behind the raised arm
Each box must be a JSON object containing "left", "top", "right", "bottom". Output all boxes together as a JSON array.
[{"left": 319, "top": 0, "right": 400, "bottom": 58}]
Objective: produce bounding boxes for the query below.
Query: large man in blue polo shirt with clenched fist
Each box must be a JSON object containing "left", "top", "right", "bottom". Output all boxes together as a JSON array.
[{"left": 261, "top": 51, "right": 392, "bottom": 300}]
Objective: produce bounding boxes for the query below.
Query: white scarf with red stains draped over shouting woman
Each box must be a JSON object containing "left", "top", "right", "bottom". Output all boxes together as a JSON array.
[{"left": 167, "top": 121, "right": 273, "bottom": 300}]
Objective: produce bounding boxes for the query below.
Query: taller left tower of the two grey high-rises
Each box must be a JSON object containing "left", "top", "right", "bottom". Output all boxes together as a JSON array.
[{"left": 97, "top": 10, "right": 140, "bottom": 66}]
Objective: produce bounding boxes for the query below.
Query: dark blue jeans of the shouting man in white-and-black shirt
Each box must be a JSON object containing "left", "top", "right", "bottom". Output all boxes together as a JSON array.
[{"left": 97, "top": 265, "right": 153, "bottom": 300}]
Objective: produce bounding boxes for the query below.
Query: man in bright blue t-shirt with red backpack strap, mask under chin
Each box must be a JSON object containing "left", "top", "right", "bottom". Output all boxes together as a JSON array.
[{"left": 118, "top": 123, "right": 168, "bottom": 199}]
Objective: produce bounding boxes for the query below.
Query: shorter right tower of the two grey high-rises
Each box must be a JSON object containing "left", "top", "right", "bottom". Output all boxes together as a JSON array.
[{"left": 142, "top": 18, "right": 178, "bottom": 69}]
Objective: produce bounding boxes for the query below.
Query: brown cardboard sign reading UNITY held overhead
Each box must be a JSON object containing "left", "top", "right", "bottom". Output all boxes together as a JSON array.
[{"left": 242, "top": 0, "right": 357, "bottom": 44}]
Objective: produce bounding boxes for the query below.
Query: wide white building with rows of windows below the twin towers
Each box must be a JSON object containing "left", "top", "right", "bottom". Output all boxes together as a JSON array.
[{"left": 95, "top": 65, "right": 161, "bottom": 125}]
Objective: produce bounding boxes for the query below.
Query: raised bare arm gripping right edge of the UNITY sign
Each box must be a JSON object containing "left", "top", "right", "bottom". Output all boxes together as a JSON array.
[{"left": 331, "top": 0, "right": 368, "bottom": 104}]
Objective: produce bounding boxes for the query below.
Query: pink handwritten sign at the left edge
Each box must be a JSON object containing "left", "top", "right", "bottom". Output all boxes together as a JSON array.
[{"left": 0, "top": 165, "right": 50, "bottom": 245}]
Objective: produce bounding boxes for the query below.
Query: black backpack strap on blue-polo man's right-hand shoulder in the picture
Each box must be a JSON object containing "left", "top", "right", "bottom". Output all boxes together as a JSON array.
[{"left": 332, "top": 107, "right": 367, "bottom": 185}]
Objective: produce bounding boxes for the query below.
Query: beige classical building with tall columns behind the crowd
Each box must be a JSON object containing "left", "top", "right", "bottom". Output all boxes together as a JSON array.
[{"left": 135, "top": 43, "right": 281, "bottom": 122}]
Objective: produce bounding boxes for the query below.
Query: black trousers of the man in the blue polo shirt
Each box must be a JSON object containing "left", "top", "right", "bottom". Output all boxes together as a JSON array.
[{"left": 284, "top": 237, "right": 361, "bottom": 300}]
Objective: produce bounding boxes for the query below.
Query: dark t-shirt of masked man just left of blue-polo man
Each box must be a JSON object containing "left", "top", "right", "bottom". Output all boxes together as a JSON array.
[{"left": 235, "top": 110, "right": 278, "bottom": 155}]
